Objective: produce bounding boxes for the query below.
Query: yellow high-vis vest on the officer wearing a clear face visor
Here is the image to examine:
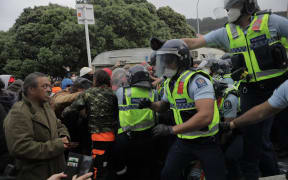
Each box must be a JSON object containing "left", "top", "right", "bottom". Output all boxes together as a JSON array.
[{"left": 165, "top": 70, "right": 220, "bottom": 139}]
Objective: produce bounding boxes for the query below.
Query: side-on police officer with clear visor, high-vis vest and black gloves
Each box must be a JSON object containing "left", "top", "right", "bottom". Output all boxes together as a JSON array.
[{"left": 139, "top": 39, "right": 226, "bottom": 180}]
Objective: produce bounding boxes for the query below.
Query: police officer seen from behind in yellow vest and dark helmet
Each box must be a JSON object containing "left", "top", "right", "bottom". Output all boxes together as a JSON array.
[{"left": 113, "top": 65, "right": 156, "bottom": 179}]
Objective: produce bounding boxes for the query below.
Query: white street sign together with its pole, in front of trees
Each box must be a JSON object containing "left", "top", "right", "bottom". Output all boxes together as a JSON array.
[{"left": 76, "top": 4, "right": 95, "bottom": 68}]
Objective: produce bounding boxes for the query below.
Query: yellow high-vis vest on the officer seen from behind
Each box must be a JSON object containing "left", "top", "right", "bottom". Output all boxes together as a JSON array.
[{"left": 118, "top": 87, "right": 155, "bottom": 133}]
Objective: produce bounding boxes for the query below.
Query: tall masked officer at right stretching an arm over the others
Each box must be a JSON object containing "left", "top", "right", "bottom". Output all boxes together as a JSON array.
[{"left": 184, "top": 0, "right": 288, "bottom": 179}]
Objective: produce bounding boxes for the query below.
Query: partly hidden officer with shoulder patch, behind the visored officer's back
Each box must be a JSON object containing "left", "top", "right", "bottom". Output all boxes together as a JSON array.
[{"left": 214, "top": 80, "right": 243, "bottom": 180}]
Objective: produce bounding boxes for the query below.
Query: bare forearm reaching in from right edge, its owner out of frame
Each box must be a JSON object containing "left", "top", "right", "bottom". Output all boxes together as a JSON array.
[{"left": 230, "top": 101, "right": 282, "bottom": 129}]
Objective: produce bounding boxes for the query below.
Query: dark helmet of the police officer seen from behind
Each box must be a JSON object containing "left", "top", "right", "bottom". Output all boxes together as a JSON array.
[{"left": 127, "top": 65, "right": 152, "bottom": 88}]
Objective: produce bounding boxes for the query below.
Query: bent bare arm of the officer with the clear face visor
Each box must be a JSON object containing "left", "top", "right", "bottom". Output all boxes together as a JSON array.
[{"left": 173, "top": 99, "right": 214, "bottom": 134}]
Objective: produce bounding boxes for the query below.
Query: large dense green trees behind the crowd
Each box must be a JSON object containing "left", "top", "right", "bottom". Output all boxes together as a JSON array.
[{"left": 0, "top": 0, "right": 193, "bottom": 78}]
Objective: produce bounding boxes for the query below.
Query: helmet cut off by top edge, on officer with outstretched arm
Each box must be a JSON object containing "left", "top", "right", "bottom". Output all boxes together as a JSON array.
[{"left": 224, "top": 0, "right": 260, "bottom": 15}]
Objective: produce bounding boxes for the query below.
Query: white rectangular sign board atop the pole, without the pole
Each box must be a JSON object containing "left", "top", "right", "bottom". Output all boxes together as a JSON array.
[{"left": 76, "top": 4, "right": 95, "bottom": 24}]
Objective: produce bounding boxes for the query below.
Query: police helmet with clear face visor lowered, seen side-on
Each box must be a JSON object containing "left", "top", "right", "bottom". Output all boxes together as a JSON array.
[{"left": 156, "top": 39, "right": 193, "bottom": 77}]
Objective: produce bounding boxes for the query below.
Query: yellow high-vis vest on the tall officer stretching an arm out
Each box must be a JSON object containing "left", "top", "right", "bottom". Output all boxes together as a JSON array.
[{"left": 226, "top": 14, "right": 287, "bottom": 82}]
